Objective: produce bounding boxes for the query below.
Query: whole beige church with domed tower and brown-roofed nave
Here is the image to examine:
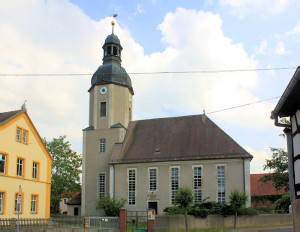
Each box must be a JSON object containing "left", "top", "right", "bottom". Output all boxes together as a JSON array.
[{"left": 81, "top": 21, "right": 253, "bottom": 216}]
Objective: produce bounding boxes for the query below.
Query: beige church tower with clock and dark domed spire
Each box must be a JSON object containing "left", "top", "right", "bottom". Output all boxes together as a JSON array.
[{"left": 81, "top": 21, "right": 134, "bottom": 216}]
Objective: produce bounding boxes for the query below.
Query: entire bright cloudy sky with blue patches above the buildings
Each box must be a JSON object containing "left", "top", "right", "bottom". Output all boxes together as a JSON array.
[{"left": 0, "top": 0, "right": 300, "bottom": 173}]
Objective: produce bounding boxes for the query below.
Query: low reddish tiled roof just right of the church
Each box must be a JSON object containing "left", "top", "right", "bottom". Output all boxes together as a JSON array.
[{"left": 250, "top": 173, "right": 285, "bottom": 196}]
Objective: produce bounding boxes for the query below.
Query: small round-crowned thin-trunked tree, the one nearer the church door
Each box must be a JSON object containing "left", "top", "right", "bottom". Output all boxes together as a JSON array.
[{"left": 175, "top": 187, "right": 194, "bottom": 232}]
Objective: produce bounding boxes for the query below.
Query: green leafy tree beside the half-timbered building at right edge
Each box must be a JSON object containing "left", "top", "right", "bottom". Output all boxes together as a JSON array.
[{"left": 259, "top": 147, "right": 289, "bottom": 191}]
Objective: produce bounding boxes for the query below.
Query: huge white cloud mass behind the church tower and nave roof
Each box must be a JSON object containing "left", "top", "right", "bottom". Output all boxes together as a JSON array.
[{"left": 0, "top": 0, "right": 274, "bottom": 156}]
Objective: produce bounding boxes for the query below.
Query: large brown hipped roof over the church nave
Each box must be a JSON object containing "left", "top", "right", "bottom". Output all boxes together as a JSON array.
[{"left": 110, "top": 115, "right": 253, "bottom": 164}]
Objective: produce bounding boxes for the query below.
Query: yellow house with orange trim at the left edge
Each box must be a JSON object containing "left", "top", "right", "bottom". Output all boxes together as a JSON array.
[{"left": 0, "top": 108, "right": 53, "bottom": 218}]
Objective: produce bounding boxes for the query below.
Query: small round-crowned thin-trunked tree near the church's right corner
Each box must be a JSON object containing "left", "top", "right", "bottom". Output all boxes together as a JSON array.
[{"left": 229, "top": 189, "right": 248, "bottom": 228}]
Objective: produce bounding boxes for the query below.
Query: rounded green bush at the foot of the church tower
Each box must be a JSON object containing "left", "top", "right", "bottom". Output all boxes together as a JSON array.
[{"left": 96, "top": 195, "right": 126, "bottom": 216}]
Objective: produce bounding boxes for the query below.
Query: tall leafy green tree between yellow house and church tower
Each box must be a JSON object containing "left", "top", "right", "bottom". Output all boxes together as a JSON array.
[{"left": 43, "top": 136, "right": 82, "bottom": 214}]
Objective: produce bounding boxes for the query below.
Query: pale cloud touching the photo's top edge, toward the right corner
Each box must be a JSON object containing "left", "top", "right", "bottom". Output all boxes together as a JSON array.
[{"left": 219, "top": 0, "right": 294, "bottom": 18}]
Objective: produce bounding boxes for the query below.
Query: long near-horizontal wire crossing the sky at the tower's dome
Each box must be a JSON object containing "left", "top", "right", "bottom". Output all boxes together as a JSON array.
[{"left": 0, "top": 67, "right": 297, "bottom": 77}]
